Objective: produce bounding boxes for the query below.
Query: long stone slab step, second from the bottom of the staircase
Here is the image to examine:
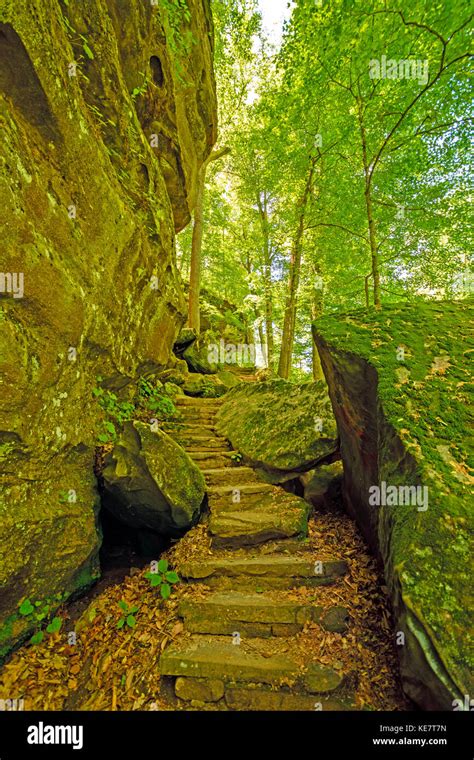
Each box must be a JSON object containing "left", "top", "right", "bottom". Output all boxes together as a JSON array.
[{"left": 178, "top": 591, "right": 348, "bottom": 638}]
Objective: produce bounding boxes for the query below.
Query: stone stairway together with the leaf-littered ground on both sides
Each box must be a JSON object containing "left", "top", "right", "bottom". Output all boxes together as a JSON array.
[{"left": 0, "top": 392, "right": 408, "bottom": 711}]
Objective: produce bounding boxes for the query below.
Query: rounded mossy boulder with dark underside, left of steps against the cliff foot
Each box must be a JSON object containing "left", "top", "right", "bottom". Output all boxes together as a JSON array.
[{"left": 101, "top": 421, "right": 206, "bottom": 538}]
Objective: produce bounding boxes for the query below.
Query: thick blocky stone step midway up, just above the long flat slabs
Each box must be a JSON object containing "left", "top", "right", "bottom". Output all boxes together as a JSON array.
[{"left": 208, "top": 490, "right": 309, "bottom": 548}]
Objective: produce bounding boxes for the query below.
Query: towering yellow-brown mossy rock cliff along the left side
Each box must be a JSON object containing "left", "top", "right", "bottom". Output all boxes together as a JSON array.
[{"left": 0, "top": 0, "right": 216, "bottom": 654}]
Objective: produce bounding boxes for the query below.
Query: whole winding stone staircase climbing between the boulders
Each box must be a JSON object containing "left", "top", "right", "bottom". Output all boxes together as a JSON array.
[{"left": 159, "top": 397, "right": 354, "bottom": 710}]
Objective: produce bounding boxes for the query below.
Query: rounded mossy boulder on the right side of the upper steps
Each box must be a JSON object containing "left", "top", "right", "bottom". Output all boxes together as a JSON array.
[{"left": 217, "top": 380, "right": 337, "bottom": 483}]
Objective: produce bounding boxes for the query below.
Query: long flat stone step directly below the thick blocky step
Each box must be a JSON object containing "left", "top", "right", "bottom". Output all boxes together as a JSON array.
[{"left": 179, "top": 554, "right": 347, "bottom": 590}]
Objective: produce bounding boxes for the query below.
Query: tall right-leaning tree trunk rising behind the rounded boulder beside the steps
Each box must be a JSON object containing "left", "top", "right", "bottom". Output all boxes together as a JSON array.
[{"left": 278, "top": 158, "right": 316, "bottom": 380}]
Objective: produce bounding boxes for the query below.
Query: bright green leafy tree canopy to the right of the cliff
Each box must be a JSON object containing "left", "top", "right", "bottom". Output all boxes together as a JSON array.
[{"left": 194, "top": 0, "right": 472, "bottom": 382}]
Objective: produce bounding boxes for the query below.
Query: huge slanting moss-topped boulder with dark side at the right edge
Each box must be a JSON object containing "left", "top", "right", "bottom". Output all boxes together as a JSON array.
[{"left": 313, "top": 302, "right": 474, "bottom": 710}]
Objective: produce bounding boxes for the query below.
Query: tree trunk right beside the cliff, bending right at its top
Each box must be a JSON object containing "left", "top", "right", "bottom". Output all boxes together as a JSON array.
[{"left": 188, "top": 148, "right": 230, "bottom": 335}]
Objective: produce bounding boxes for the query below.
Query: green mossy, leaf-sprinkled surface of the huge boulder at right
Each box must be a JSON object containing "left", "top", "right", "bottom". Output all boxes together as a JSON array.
[{"left": 313, "top": 300, "right": 474, "bottom": 700}]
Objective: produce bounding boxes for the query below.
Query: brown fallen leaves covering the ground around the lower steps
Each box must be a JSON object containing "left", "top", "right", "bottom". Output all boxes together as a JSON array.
[{"left": 0, "top": 394, "right": 410, "bottom": 711}]
